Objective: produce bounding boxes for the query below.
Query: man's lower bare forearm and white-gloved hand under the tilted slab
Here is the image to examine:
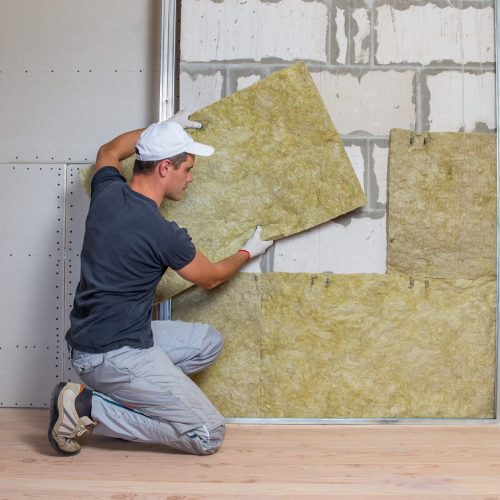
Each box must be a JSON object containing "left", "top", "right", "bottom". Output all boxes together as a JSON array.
[{"left": 177, "top": 226, "right": 274, "bottom": 289}]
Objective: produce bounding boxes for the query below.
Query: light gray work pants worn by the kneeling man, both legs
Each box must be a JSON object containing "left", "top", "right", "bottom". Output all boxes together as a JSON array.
[{"left": 72, "top": 321, "right": 224, "bottom": 455}]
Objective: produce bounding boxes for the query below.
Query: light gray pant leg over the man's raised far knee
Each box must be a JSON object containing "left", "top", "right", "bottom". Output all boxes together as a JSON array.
[{"left": 151, "top": 321, "right": 224, "bottom": 374}]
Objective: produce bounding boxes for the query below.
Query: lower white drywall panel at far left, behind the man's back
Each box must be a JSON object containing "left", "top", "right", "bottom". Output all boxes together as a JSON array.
[{"left": 0, "top": 164, "right": 65, "bottom": 406}]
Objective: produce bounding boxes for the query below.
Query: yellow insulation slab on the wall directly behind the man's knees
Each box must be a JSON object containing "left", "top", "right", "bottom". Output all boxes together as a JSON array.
[{"left": 172, "top": 273, "right": 262, "bottom": 417}]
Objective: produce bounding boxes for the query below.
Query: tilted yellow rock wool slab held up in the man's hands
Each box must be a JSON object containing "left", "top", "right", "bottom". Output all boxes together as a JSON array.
[{"left": 83, "top": 63, "right": 366, "bottom": 301}]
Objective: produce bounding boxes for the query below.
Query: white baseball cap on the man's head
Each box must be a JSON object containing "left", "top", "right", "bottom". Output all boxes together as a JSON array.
[{"left": 135, "top": 121, "right": 214, "bottom": 161}]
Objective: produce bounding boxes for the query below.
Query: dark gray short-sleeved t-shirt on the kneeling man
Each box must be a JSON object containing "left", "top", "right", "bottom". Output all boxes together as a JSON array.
[{"left": 66, "top": 167, "right": 196, "bottom": 353}]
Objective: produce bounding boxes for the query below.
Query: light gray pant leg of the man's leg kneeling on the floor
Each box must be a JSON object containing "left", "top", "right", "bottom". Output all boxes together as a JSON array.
[{"left": 73, "top": 346, "right": 224, "bottom": 454}]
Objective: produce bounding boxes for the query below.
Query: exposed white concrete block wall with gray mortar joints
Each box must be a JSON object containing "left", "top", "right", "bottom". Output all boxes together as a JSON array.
[{"left": 180, "top": 0, "right": 496, "bottom": 273}]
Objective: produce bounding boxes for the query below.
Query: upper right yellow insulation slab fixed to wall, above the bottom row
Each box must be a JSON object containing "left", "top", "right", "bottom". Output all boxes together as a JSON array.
[{"left": 387, "top": 130, "right": 496, "bottom": 279}]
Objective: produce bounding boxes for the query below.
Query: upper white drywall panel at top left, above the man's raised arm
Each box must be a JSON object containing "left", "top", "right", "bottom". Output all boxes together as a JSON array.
[{"left": 0, "top": 0, "right": 161, "bottom": 163}]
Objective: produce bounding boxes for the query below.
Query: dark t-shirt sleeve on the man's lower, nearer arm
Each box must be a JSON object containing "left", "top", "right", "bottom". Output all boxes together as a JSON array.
[{"left": 160, "top": 221, "right": 196, "bottom": 271}]
